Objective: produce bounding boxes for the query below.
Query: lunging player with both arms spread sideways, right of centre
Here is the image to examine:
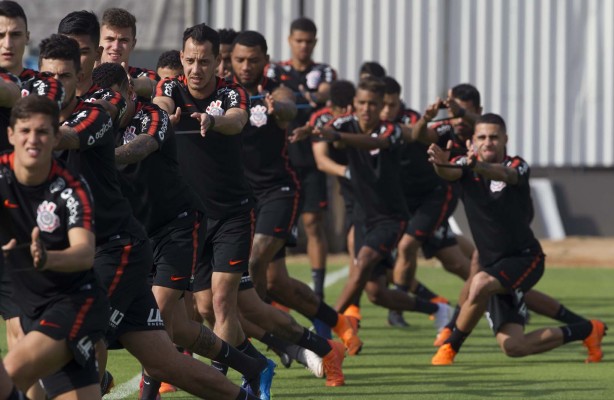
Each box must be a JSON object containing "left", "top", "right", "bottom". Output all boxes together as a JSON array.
[{"left": 313, "top": 77, "right": 449, "bottom": 332}]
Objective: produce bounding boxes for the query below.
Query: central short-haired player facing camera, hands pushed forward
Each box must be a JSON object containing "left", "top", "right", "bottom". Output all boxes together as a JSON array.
[{"left": 154, "top": 24, "right": 274, "bottom": 388}]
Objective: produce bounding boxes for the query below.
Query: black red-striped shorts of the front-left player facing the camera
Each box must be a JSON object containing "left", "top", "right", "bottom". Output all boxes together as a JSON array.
[{"left": 20, "top": 285, "right": 109, "bottom": 398}]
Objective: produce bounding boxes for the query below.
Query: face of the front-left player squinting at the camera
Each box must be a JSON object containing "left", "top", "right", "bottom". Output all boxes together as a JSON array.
[{"left": 7, "top": 114, "right": 60, "bottom": 169}]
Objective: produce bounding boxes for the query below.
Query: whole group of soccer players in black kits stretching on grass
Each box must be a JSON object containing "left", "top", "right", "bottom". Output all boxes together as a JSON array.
[{"left": 0, "top": 0, "right": 607, "bottom": 400}]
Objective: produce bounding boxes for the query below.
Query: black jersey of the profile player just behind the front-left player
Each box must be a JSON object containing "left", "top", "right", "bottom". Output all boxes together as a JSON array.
[{"left": 63, "top": 101, "right": 143, "bottom": 244}]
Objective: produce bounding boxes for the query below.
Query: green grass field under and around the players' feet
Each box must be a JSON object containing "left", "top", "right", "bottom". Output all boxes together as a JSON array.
[{"left": 0, "top": 265, "right": 614, "bottom": 400}]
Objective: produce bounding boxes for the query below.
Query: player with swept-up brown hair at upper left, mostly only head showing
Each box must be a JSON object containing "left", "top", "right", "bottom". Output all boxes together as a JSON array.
[{"left": 100, "top": 8, "right": 160, "bottom": 101}]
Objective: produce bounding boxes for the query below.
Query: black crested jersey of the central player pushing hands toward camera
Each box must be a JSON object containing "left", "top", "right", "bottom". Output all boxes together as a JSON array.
[{"left": 156, "top": 75, "right": 254, "bottom": 219}]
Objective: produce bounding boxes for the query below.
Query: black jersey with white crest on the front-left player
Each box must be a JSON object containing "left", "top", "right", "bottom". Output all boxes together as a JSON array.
[{"left": 0, "top": 153, "right": 98, "bottom": 319}]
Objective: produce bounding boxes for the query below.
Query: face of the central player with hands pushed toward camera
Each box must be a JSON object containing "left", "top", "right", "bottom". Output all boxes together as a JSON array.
[{"left": 181, "top": 38, "right": 222, "bottom": 92}]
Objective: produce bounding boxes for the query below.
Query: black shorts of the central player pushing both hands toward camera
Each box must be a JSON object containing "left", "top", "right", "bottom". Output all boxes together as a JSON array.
[{"left": 192, "top": 210, "right": 254, "bottom": 292}]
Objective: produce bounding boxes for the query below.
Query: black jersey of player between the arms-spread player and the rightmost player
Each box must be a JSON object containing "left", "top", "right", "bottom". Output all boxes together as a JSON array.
[{"left": 395, "top": 105, "right": 444, "bottom": 197}]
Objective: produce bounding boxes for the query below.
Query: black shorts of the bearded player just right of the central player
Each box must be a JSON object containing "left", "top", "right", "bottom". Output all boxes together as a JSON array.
[{"left": 255, "top": 192, "right": 300, "bottom": 247}]
